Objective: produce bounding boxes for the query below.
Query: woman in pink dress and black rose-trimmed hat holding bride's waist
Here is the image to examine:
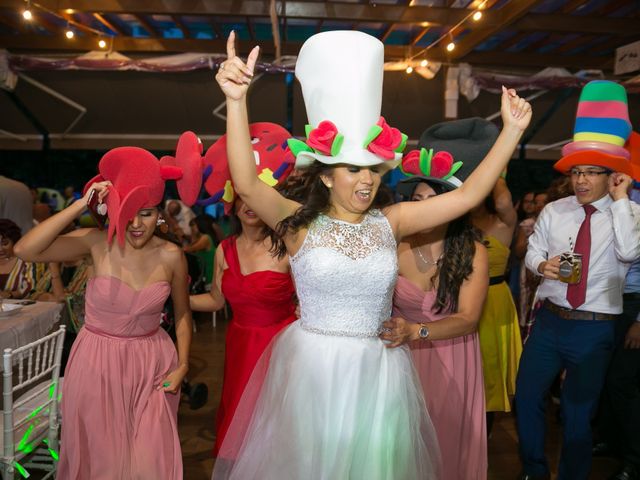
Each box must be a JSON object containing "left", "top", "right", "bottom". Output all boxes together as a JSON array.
[{"left": 387, "top": 119, "right": 493, "bottom": 480}]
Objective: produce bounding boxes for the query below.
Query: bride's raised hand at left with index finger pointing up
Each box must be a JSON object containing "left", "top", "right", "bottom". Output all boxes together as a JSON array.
[{"left": 216, "top": 32, "right": 260, "bottom": 100}]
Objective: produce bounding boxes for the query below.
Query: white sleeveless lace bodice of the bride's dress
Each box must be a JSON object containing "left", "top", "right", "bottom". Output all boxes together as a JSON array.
[{"left": 291, "top": 210, "right": 398, "bottom": 337}]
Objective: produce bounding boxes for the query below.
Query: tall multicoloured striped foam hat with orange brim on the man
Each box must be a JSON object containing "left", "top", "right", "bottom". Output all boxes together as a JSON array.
[{"left": 554, "top": 80, "right": 632, "bottom": 175}]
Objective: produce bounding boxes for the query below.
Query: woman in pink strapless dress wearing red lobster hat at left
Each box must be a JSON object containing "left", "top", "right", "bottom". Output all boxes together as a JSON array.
[{"left": 16, "top": 141, "right": 201, "bottom": 480}]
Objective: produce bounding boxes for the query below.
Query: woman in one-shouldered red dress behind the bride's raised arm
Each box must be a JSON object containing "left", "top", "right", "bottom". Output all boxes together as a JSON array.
[{"left": 190, "top": 123, "right": 296, "bottom": 455}]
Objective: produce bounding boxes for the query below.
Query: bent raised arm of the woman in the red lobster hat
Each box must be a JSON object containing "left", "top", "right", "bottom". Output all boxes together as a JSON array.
[{"left": 14, "top": 182, "right": 110, "bottom": 262}]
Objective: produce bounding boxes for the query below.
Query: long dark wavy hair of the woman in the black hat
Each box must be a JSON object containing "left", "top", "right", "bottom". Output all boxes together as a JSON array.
[{"left": 410, "top": 182, "right": 482, "bottom": 313}]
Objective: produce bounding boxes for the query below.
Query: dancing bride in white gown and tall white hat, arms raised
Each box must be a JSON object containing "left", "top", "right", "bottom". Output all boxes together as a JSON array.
[{"left": 213, "top": 31, "right": 531, "bottom": 480}]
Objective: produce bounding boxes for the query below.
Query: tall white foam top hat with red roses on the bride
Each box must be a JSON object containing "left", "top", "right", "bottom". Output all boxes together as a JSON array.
[{"left": 289, "top": 31, "right": 407, "bottom": 168}]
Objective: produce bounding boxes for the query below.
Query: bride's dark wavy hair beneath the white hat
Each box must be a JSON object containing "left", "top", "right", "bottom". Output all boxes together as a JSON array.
[{"left": 271, "top": 161, "right": 391, "bottom": 258}]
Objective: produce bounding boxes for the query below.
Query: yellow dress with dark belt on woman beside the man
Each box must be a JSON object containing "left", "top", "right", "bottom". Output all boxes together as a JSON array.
[{"left": 478, "top": 236, "right": 522, "bottom": 412}]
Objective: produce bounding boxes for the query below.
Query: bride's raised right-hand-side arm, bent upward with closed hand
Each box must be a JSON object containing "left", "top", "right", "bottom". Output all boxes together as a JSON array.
[{"left": 385, "top": 87, "right": 531, "bottom": 239}]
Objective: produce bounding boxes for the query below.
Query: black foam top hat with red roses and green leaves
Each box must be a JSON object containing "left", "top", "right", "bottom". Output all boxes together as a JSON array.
[{"left": 396, "top": 118, "right": 500, "bottom": 197}]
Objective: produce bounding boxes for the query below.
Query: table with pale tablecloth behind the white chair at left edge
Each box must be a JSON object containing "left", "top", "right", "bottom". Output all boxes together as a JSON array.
[{"left": 0, "top": 300, "right": 64, "bottom": 371}]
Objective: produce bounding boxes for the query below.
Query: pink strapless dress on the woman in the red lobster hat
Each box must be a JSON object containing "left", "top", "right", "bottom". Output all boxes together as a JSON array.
[{"left": 57, "top": 276, "right": 182, "bottom": 480}]
